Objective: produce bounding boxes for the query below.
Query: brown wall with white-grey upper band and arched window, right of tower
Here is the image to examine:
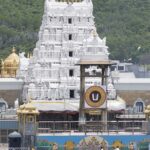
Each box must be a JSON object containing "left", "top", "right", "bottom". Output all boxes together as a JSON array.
[{"left": 115, "top": 81, "right": 150, "bottom": 111}]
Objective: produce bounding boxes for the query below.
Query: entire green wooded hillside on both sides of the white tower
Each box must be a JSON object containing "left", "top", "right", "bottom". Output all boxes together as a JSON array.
[{"left": 0, "top": 0, "right": 150, "bottom": 62}]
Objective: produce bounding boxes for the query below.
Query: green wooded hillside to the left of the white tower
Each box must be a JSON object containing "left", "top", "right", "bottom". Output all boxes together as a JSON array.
[{"left": 0, "top": 0, "right": 44, "bottom": 58}]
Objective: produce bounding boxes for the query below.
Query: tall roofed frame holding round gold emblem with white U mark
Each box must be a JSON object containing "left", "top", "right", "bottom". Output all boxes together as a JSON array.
[{"left": 78, "top": 60, "right": 112, "bottom": 130}]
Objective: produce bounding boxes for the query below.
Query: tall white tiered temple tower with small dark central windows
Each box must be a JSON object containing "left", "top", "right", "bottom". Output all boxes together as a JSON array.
[{"left": 23, "top": 0, "right": 109, "bottom": 100}]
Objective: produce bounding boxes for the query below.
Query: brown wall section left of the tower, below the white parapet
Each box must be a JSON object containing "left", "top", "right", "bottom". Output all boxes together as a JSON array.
[{"left": 0, "top": 90, "right": 22, "bottom": 108}]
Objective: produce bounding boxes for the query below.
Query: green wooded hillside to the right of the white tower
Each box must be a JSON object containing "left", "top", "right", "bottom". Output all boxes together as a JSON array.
[{"left": 93, "top": 0, "right": 150, "bottom": 62}]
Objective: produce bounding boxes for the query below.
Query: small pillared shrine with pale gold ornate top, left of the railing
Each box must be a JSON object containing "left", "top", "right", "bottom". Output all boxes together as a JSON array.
[{"left": 17, "top": 101, "right": 39, "bottom": 148}]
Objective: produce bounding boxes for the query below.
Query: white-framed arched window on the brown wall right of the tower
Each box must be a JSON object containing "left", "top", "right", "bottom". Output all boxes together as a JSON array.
[{"left": 134, "top": 98, "right": 145, "bottom": 113}]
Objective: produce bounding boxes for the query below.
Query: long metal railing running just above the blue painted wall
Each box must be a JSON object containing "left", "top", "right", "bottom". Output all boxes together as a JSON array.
[{"left": 38, "top": 120, "right": 148, "bottom": 134}]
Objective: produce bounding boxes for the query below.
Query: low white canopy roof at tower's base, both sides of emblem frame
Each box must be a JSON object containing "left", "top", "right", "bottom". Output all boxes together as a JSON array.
[{"left": 28, "top": 97, "right": 126, "bottom": 113}]
